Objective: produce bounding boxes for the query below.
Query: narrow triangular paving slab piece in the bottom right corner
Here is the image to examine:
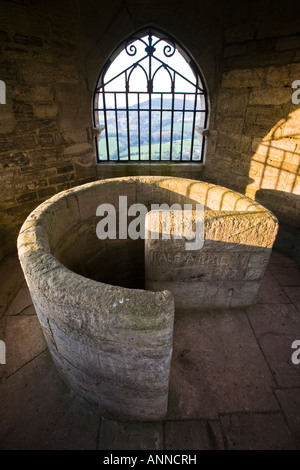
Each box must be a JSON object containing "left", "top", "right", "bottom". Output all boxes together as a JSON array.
[{"left": 276, "top": 388, "right": 300, "bottom": 450}]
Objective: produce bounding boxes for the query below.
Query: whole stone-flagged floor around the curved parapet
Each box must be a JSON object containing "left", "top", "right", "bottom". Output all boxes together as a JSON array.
[{"left": 0, "top": 252, "right": 300, "bottom": 450}]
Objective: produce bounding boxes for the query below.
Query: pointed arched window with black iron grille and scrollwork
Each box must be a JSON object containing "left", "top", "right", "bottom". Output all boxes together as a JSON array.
[{"left": 94, "top": 28, "right": 208, "bottom": 163}]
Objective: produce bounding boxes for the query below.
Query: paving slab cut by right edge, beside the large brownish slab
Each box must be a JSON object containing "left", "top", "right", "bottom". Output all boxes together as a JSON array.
[{"left": 248, "top": 304, "right": 300, "bottom": 387}]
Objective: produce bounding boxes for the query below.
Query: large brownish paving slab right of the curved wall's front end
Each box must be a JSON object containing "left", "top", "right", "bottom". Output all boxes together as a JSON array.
[{"left": 168, "top": 310, "right": 278, "bottom": 419}]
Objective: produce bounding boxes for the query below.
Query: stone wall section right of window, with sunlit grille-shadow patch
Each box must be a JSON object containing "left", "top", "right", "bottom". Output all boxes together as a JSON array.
[{"left": 205, "top": 2, "right": 300, "bottom": 258}]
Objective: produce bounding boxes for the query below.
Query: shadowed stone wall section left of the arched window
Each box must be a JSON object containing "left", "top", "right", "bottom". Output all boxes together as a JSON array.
[{"left": 0, "top": 1, "right": 96, "bottom": 258}]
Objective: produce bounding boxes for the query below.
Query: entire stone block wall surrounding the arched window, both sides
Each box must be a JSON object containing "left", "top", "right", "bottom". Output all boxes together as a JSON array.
[{"left": 0, "top": 0, "right": 300, "bottom": 259}]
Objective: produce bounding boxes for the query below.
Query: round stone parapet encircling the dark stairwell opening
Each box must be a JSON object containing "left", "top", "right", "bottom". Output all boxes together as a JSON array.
[{"left": 18, "top": 177, "right": 277, "bottom": 420}]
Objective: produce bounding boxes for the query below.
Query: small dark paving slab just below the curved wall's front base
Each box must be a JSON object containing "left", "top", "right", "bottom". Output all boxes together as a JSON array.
[{"left": 99, "top": 418, "right": 163, "bottom": 450}]
